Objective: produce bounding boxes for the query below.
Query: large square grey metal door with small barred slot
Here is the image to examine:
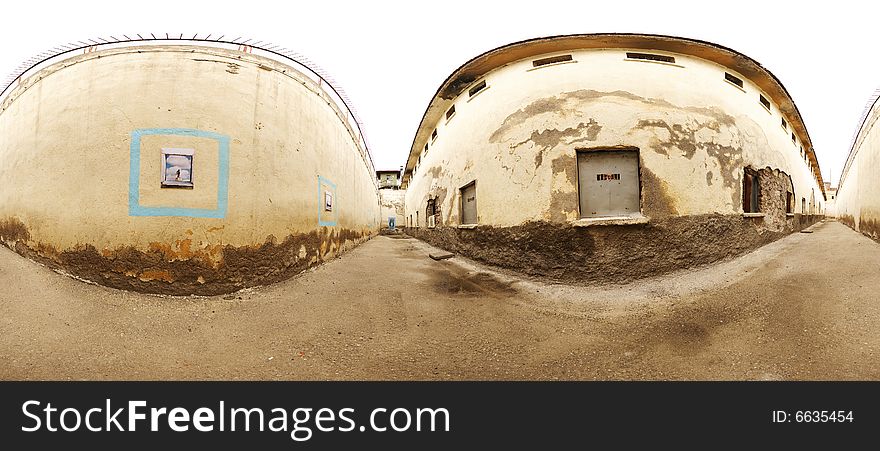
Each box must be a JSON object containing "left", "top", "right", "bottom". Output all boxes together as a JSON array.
[{"left": 578, "top": 150, "right": 641, "bottom": 218}]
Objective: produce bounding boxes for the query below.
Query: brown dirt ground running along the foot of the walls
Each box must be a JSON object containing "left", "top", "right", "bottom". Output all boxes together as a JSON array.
[{"left": 0, "top": 222, "right": 880, "bottom": 380}]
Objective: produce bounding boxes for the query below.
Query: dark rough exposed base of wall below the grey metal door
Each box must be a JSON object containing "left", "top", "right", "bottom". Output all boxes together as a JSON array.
[{"left": 406, "top": 214, "right": 821, "bottom": 284}]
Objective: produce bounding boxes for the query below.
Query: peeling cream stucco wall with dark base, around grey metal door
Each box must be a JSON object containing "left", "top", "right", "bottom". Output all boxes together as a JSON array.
[{"left": 405, "top": 44, "right": 824, "bottom": 281}]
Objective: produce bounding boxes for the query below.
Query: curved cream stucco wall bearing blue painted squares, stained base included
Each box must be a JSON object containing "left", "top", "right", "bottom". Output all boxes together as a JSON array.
[{"left": 0, "top": 46, "right": 379, "bottom": 294}]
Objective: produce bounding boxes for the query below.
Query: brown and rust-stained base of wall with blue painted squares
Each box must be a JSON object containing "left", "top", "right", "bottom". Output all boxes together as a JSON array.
[{"left": 0, "top": 219, "right": 372, "bottom": 296}]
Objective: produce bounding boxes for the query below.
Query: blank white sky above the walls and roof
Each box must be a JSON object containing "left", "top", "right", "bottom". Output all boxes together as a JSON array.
[{"left": 0, "top": 0, "right": 880, "bottom": 184}]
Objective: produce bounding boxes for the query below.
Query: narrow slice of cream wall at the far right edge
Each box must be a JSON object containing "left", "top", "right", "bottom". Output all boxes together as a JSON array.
[{"left": 835, "top": 98, "right": 880, "bottom": 240}]
